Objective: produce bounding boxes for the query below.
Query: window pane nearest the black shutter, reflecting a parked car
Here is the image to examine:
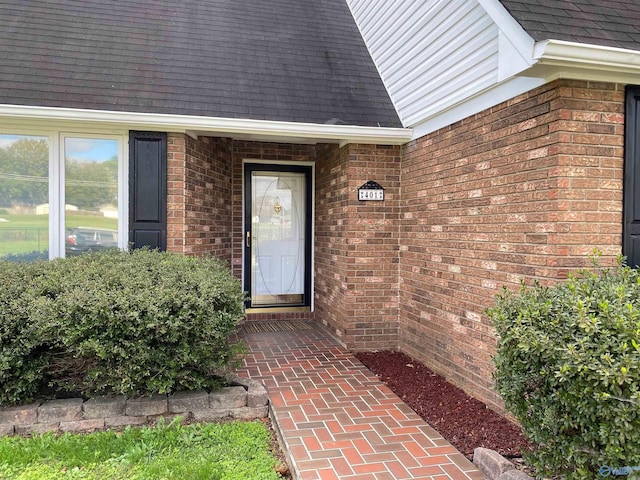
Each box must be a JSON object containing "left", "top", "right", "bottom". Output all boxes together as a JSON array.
[{"left": 64, "top": 137, "right": 119, "bottom": 256}]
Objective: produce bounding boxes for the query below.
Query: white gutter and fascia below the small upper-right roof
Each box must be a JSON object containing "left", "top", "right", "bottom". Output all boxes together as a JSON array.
[{"left": 533, "top": 40, "right": 640, "bottom": 75}]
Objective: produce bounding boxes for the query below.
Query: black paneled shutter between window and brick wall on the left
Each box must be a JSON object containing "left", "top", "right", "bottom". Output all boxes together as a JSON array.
[{"left": 129, "top": 132, "right": 167, "bottom": 251}]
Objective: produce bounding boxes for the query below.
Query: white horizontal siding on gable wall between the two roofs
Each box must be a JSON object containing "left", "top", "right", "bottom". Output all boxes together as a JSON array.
[{"left": 347, "top": 0, "right": 499, "bottom": 127}]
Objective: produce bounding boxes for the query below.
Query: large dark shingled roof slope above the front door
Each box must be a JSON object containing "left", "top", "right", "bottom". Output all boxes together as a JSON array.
[{"left": 0, "top": 0, "right": 400, "bottom": 127}]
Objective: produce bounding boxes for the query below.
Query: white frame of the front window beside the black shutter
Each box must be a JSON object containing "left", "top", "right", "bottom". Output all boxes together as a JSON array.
[{"left": 0, "top": 124, "right": 129, "bottom": 260}]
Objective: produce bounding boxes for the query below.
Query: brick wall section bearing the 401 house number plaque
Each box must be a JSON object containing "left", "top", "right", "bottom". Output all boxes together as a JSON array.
[{"left": 315, "top": 145, "right": 401, "bottom": 350}]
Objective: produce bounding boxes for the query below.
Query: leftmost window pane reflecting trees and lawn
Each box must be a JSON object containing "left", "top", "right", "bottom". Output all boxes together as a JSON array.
[{"left": 0, "top": 134, "right": 49, "bottom": 260}]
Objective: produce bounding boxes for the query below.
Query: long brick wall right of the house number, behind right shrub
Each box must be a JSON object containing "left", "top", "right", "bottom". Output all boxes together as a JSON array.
[{"left": 400, "top": 81, "right": 624, "bottom": 409}]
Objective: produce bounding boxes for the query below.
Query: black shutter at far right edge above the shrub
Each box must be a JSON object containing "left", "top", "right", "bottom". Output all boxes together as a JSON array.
[{"left": 622, "top": 86, "right": 640, "bottom": 267}]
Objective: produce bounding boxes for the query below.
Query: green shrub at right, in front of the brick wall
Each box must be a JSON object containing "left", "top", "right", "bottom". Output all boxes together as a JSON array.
[{"left": 488, "top": 263, "right": 640, "bottom": 479}]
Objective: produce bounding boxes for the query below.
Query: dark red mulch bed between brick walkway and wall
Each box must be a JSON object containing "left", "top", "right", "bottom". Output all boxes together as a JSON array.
[{"left": 356, "top": 351, "right": 529, "bottom": 458}]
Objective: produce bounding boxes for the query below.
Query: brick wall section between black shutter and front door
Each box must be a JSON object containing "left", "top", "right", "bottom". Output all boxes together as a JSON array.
[{"left": 167, "top": 133, "right": 232, "bottom": 263}]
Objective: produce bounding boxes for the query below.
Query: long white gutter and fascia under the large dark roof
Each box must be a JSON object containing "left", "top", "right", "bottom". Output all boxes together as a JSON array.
[{"left": 0, "top": 105, "right": 413, "bottom": 145}]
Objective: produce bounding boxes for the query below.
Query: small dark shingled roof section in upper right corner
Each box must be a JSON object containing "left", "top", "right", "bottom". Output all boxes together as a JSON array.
[{"left": 500, "top": 0, "right": 640, "bottom": 50}]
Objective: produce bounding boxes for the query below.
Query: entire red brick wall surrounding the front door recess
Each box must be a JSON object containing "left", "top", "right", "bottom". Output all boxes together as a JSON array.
[{"left": 168, "top": 81, "right": 624, "bottom": 409}]
